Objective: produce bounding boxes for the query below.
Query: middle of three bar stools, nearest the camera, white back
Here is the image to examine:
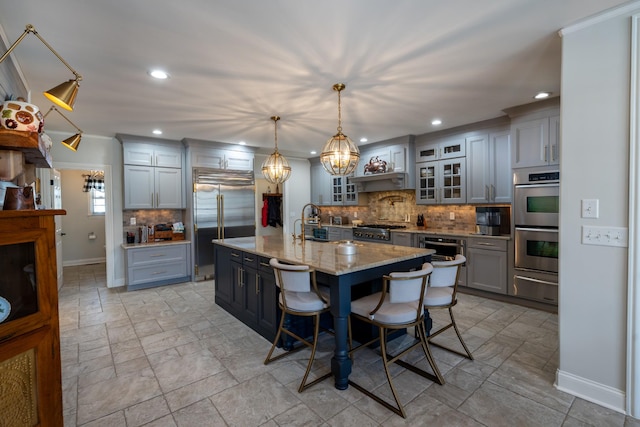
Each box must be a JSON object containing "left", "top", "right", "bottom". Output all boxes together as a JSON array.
[{"left": 349, "top": 263, "right": 444, "bottom": 418}]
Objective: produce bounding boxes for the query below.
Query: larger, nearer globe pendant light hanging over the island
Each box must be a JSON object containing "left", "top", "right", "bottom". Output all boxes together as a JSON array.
[{"left": 320, "top": 83, "right": 360, "bottom": 176}]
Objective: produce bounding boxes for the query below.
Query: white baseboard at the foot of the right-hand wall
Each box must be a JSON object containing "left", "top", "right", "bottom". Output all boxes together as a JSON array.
[{"left": 554, "top": 370, "right": 626, "bottom": 414}]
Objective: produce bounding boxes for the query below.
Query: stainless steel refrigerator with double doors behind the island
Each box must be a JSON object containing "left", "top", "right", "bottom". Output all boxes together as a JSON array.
[{"left": 193, "top": 169, "right": 256, "bottom": 280}]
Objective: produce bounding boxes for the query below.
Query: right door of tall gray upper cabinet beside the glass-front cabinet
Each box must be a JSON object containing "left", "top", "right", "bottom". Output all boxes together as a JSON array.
[{"left": 492, "top": 131, "right": 513, "bottom": 203}]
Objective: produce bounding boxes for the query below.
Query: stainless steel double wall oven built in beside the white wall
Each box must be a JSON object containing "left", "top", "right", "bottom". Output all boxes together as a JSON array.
[{"left": 509, "top": 168, "right": 560, "bottom": 305}]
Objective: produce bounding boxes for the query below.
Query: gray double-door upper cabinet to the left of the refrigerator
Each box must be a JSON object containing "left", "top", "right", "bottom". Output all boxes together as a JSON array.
[{"left": 117, "top": 135, "right": 186, "bottom": 209}]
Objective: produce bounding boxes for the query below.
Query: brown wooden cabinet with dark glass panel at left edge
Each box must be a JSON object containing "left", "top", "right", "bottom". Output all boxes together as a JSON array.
[{"left": 0, "top": 210, "right": 65, "bottom": 426}]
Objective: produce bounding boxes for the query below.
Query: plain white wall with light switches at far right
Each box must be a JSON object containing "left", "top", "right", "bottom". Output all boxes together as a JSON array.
[{"left": 557, "top": 4, "right": 640, "bottom": 412}]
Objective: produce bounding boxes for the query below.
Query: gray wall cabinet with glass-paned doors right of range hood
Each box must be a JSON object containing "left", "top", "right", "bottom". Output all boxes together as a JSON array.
[{"left": 416, "top": 157, "right": 467, "bottom": 205}]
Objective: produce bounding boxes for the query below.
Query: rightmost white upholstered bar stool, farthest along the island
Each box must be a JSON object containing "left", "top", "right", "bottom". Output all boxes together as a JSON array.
[{"left": 424, "top": 254, "right": 473, "bottom": 360}]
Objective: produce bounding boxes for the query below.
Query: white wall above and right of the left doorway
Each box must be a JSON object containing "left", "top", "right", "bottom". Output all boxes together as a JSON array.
[{"left": 47, "top": 132, "right": 125, "bottom": 287}]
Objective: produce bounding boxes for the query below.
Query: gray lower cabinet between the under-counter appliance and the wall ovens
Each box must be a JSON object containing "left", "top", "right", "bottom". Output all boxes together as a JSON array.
[{"left": 466, "top": 237, "right": 507, "bottom": 294}]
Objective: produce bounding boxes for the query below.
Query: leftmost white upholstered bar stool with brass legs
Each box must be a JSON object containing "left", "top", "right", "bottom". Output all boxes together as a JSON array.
[{"left": 264, "top": 258, "right": 332, "bottom": 393}]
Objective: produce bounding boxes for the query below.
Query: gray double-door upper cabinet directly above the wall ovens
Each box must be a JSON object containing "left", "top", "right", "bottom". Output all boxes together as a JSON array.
[{"left": 505, "top": 98, "right": 560, "bottom": 168}]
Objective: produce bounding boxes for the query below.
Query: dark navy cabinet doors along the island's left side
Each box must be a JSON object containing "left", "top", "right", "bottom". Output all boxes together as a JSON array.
[{"left": 213, "top": 245, "right": 279, "bottom": 340}]
